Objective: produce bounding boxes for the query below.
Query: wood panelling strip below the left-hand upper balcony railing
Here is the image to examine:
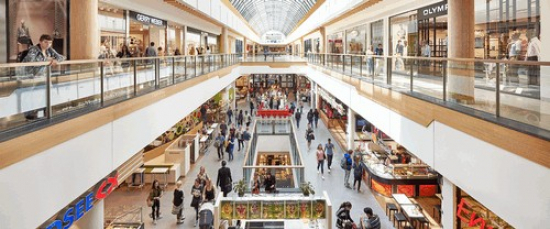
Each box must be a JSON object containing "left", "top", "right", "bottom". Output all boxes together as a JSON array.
[{"left": 0, "top": 65, "right": 236, "bottom": 169}]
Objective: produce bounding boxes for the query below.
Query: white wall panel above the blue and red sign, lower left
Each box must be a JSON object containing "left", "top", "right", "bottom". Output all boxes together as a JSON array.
[{"left": 0, "top": 123, "right": 113, "bottom": 229}]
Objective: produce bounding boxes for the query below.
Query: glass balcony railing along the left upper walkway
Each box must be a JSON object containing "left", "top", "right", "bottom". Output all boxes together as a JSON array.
[{"left": 0, "top": 54, "right": 241, "bottom": 141}]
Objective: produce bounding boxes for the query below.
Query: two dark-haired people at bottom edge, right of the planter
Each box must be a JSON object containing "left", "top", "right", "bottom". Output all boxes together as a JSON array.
[{"left": 336, "top": 201, "right": 381, "bottom": 229}]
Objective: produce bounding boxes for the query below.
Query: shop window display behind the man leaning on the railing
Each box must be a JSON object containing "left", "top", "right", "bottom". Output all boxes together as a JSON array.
[{"left": 8, "top": 0, "right": 68, "bottom": 62}]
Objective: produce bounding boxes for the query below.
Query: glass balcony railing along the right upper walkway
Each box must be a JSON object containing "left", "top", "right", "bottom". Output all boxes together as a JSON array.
[{"left": 307, "top": 54, "right": 550, "bottom": 139}]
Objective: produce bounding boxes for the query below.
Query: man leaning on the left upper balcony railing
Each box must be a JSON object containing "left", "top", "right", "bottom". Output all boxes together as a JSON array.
[{"left": 23, "top": 34, "right": 65, "bottom": 76}]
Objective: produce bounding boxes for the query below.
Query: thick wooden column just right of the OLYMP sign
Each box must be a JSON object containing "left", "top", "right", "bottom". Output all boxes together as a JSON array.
[{"left": 448, "top": 0, "right": 475, "bottom": 104}]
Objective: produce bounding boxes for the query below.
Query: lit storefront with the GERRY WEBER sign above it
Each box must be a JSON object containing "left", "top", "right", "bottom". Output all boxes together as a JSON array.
[{"left": 128, "top": 11, "right": 168, "bottom": 57}]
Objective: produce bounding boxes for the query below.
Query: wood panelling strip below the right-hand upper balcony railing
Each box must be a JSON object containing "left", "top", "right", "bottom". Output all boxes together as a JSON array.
[{"left": 311, "top": 66, "right": 550, "bottom": 168}]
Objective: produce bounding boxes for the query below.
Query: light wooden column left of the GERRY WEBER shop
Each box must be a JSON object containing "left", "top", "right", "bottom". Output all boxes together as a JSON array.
[{"left": 69, "top": 0, "right": 100, "bottom": 60}]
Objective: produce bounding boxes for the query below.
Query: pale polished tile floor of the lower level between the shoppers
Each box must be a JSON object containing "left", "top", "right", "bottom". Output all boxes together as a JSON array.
[{"left": 105, "top": 101, "right": 393, "bottom": 228}]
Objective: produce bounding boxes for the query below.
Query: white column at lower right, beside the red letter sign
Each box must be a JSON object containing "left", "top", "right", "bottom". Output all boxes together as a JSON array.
[{"left": 441, "top": 178, "right": 456, "bottom": 228}]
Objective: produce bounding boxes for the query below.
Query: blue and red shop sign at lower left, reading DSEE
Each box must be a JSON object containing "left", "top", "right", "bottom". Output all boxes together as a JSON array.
[{"left": 38, "top": 171, "right": 118, "bottom": 229}]
